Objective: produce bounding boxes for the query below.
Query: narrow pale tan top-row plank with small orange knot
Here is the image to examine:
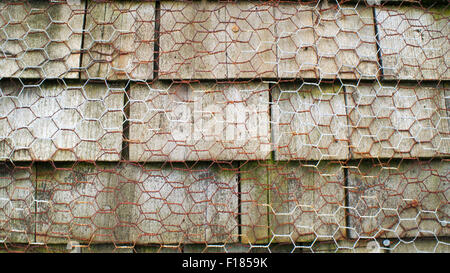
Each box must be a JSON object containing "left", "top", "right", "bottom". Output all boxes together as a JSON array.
[{"left": 225, "top": 1, "right": 277, "bottom": 79}]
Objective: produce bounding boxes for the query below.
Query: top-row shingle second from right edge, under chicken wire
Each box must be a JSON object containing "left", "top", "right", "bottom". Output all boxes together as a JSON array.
[{"left": 275, "top": 1, "right": 378, "bottom": 79}]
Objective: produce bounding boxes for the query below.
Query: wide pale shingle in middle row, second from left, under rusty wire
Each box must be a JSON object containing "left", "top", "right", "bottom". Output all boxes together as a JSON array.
[{"left": 129, "top": 82, "right": 270, "bottom": 161}]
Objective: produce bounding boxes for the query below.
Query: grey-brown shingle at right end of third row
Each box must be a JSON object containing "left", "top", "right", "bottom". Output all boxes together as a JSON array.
[{"left": 348, "top": 159, "right": 450, "bottom": 238}]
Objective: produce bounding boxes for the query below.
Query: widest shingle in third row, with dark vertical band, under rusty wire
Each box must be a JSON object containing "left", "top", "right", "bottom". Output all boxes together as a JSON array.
[{"left": 37, "top": 163, "right": 238, "bottom": 244}]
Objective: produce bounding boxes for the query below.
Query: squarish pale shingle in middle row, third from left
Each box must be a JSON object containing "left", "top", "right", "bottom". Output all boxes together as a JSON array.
[{"left": 272, "top": 83, "right": 349, "bottom": 160}]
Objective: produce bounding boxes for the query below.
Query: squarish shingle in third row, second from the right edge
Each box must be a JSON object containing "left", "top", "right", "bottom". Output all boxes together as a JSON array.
[{"left": 268, "top": 161, "right": 346, "bottom": 242}]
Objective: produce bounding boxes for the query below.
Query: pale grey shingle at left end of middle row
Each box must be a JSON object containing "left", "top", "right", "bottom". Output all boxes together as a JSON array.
[{"left": 0, "top": 81, "right": 124, "bottom": 161}]
